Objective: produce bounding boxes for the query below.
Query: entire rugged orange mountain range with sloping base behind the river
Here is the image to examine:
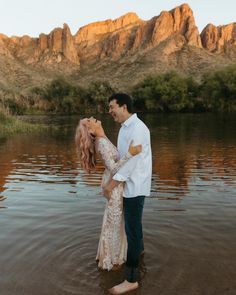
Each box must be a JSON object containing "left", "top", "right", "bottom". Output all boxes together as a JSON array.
[{"left": 0, "top": 4, "right": 236, "bottom": 90}]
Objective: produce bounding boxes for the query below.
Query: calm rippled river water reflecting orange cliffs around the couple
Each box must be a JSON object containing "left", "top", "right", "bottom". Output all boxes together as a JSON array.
[{"left": 0, "top": 114, "right": 236, "bottom": 295}]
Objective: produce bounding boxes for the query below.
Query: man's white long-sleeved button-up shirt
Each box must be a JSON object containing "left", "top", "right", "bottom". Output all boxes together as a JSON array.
[{"left": 113, "top": 114, "right": 152, "bottom": 198}]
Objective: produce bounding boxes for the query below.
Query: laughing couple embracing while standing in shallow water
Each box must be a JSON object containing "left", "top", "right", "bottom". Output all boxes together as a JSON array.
[{"left": 75, "top": 93, "right": 152, "bottom": 294}]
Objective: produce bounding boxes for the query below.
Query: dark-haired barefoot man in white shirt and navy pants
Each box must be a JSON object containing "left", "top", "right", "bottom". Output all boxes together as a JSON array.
[{"left": 103, "top": 93, "right": 152, "bottom": 294}]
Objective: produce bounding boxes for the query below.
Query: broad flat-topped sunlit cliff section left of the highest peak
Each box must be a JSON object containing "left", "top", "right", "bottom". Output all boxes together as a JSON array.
[{"left": 75, "top": 13, "right": 143, "bottom": 63}]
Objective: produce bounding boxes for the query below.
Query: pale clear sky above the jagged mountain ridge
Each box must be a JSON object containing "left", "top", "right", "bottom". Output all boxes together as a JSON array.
[{"left": 0, "top": 0, "right": 236, "bottom": 37}]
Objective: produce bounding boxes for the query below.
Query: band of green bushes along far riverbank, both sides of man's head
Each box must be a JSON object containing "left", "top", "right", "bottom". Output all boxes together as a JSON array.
[{"left": 2, "top": 66, "right": 236, "bottom": 114}]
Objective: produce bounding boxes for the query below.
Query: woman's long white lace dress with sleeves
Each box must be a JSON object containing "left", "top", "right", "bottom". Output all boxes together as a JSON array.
[{"left": 95, "top": 137, "right": 132, "bottom": 270}]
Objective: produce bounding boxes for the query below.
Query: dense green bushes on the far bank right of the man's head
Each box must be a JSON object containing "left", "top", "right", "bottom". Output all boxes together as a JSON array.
[{"left": 132, "top": 66, "right": 236, "bottom": 112}]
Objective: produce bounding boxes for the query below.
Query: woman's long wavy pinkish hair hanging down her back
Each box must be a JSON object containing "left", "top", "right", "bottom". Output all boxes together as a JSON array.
[{"left": 75, "top": 119, "right": 96, "bottom": 173}]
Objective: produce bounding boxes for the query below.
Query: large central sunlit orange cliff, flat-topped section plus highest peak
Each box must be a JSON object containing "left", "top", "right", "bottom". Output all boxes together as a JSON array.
[{"left": 75, "top": 4, "right": 202, "bottom": 60}]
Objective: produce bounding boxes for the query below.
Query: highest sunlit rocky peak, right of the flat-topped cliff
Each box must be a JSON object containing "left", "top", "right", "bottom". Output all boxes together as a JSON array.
[{"left": 133, "top": 4, "right": 202, "bottom": 55}]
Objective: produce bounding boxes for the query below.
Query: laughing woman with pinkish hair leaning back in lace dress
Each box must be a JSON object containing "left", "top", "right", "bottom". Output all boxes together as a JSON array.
[{"left": 75, "top": 117, "right": 142, "bottom": 270}]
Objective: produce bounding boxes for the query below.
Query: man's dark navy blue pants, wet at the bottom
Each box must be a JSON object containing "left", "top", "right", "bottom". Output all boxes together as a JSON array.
[{"left": 123, "top": 196, "right": 145, "bottom": 283}]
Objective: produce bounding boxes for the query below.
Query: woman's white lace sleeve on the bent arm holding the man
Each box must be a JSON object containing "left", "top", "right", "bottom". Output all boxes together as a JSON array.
[{"left": 97, "top": 138, "right": 132, "bottom": 175}]
